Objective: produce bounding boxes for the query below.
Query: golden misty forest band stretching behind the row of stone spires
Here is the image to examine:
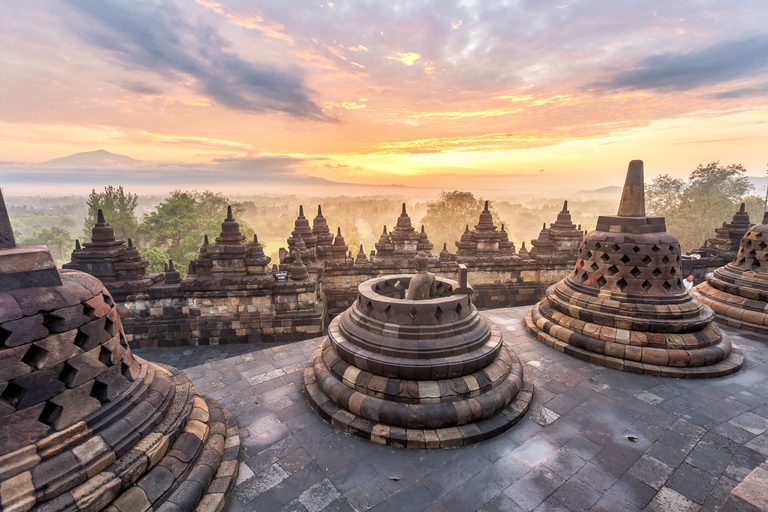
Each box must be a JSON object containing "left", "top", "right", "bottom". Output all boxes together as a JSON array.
[{"left": 6, "top": 162, "right": 764, "bottom": 271}]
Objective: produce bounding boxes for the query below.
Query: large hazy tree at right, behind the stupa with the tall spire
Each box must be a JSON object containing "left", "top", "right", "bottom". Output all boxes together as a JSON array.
[{"left": 646, "top": 161, "right": 761, "bottom": 251}]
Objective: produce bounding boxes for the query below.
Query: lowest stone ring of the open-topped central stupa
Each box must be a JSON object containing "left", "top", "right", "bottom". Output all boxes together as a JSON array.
[{"left": 304, "top": 344, "right": 533, "bottom": 449}]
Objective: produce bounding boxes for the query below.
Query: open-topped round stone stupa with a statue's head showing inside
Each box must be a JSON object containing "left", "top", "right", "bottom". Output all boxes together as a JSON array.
[{"left": 304, "top": 265, "right": 533, "bottom": 448}]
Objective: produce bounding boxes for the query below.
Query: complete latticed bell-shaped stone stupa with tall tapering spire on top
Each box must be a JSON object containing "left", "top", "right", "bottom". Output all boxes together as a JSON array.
[{"left": 525, "top": 160, "right": 743, "bottom": 378}]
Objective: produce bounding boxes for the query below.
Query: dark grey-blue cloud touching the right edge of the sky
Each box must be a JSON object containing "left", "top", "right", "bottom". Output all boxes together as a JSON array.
[{"left": 595, "top": 35, "right": 768, "bottom": 92}]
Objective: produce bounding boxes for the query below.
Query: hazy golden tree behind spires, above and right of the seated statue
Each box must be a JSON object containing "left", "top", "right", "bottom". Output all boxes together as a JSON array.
[{"left": 416, "top": 190, "right": 501, "bottom": 252}]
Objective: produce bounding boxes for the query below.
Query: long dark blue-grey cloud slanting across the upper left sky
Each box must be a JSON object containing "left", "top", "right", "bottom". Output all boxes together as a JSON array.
[{"left": 66, "top": 0, "right": 329, "bottom": 121}]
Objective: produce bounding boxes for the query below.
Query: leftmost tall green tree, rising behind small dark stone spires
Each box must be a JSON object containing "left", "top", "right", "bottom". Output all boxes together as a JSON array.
[{"left": 83, "top": 185, "right": 139, "bottom": 241}]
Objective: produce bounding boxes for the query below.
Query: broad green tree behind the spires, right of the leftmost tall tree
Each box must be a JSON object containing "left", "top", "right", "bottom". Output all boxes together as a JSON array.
[{"left": 141, "top": 190, "right": 253, "bottom": 274}]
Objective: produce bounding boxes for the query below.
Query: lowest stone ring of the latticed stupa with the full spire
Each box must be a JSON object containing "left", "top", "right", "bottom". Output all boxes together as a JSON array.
[{"left": 525, "top": 313, "right": 744, "bottom": 379}]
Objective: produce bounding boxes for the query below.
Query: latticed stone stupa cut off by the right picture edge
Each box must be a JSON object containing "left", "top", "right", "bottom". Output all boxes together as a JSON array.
[{"left": 695, "top": 213, "right": 768, "bottom": 334}]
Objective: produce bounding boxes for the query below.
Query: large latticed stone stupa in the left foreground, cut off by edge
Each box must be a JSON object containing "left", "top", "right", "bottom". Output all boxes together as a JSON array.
[{"left": 0, "top": 192, "right": 240, "bottom": 512}]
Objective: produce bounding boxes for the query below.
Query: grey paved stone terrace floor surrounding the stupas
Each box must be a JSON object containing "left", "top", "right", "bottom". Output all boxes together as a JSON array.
[{"left": 135, "top": 307, "right": 768, "bottom": 512}]
